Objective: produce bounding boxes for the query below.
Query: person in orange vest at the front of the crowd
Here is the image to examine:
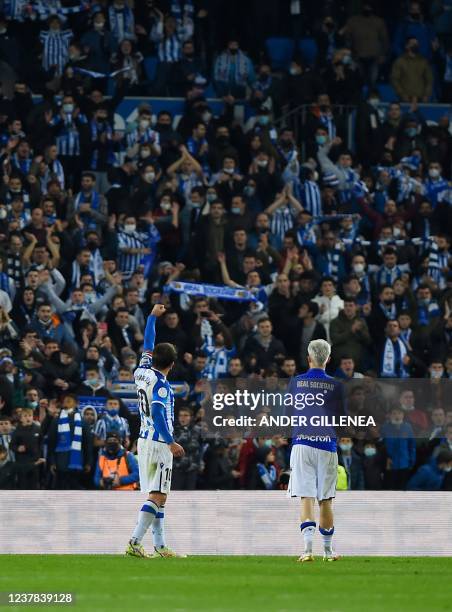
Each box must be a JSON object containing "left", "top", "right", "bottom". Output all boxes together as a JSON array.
[{"left": 94, "top": 432, "right": 139, "bottom": 491}]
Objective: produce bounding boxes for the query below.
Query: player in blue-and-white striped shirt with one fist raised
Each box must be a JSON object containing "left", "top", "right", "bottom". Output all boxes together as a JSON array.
[{"left": 126, "top": 304, "right": 184, "bottom": 559}]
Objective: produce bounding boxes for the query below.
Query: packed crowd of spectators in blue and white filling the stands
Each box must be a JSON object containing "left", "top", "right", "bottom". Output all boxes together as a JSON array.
[{"left": 0, "top": 0, "right": 452, "bottom": 490}]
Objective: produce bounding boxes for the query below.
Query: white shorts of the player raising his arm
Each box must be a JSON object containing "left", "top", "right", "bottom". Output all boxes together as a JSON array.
[{"left": 137, "top": 438, "right": 173, "bottom": 495}]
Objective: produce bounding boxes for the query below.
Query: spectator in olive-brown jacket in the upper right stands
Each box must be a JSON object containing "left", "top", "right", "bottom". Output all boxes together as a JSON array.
[{"left": 391, "top": 37, "right": 433, "bottom": 102}]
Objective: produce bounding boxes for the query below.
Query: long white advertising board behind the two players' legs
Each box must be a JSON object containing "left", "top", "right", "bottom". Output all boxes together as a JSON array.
[{"left": 0, "top": 491, "right": 452, "bottom": 556}]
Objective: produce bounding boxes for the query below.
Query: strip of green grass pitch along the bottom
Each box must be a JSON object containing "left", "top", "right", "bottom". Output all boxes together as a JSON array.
[{"left": 0, "top": 556, "right": 452, "bottom": 612}]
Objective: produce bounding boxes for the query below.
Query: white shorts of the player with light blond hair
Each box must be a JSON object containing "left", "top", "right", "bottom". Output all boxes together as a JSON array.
[{"left": 287, "top": 444, "right": 337, "bottom": 501}]
